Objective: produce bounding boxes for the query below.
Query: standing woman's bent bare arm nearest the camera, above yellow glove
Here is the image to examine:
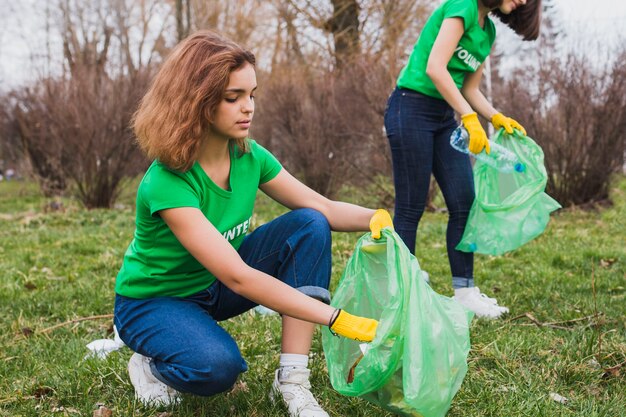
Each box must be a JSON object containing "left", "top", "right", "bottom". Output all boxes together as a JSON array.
[{"left": 426, "top": 17, "right": 480, "bottom": 114}]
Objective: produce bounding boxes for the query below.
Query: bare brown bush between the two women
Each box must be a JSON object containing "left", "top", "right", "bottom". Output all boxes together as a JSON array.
[{"left": 253, "top": 59, "right": 393, "bottom": 197}]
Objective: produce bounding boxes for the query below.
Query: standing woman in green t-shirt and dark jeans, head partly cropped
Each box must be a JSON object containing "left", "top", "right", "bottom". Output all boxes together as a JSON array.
[{"left": 385, "top": 0, "right": 541, "bottom": 318}]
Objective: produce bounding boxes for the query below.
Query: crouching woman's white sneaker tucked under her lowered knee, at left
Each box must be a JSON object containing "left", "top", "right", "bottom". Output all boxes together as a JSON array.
[{"left": 128, "top": 353, "right": 180, "bottom": 406}]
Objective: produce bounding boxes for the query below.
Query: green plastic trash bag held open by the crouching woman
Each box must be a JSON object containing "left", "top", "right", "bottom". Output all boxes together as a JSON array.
[{"left": 322, "top": 229, "right": 473, "bottom": 417}]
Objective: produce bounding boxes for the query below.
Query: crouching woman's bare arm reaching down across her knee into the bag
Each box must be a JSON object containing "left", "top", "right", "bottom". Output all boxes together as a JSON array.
[{"left": 159, "top": 207, "right": 335, "bottom": 325}]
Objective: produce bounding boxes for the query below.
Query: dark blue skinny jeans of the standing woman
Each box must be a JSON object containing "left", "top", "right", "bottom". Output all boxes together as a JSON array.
[{"left": 385, "top": 88, "right": 474, "bottom": 281}]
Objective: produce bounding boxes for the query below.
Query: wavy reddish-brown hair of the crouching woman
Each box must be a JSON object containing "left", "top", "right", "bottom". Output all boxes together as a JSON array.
[{"left": 132, "top": 31, "right": 255, "bottom": 172}]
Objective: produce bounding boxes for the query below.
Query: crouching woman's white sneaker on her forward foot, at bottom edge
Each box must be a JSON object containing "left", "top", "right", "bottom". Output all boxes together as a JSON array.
[{"left": 270, "top": 368, "right": 329, "bottom": 417}]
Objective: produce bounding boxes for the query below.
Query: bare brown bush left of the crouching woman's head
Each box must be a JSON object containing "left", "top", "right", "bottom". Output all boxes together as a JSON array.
[{"left": 15, "top": 68, "right": 148, "bottom": 208}]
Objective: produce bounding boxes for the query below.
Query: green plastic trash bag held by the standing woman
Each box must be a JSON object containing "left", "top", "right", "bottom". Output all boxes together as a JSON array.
[{"left": 456, "top": 129, "right": 561, "bottom": 255}]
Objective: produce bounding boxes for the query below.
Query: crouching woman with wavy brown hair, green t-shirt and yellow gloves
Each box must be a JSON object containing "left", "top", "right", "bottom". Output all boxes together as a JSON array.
[{"left": 115, "top": 31, "right": 391, "bottom": 417}]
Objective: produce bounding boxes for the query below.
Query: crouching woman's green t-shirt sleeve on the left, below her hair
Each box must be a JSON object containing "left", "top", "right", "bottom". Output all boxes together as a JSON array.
[{"left": 139, "top": 166, "right": 200, "bottom": 215}]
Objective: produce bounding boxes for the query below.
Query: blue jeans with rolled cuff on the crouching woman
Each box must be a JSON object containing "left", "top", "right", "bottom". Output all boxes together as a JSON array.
[{"left": 114, "top": 209, "right": 331, "bottom": 396}]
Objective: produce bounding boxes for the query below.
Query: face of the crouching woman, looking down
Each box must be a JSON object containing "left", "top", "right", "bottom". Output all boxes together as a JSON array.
[{"left": 211, "top": 63, "right": 256, "bottom": 139}]
